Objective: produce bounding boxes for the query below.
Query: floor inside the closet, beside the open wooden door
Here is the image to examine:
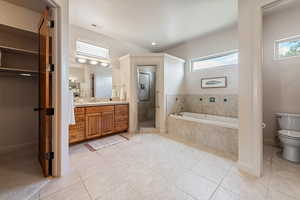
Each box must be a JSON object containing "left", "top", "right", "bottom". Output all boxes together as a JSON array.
[{"left": 0, "top": 145, "right": 48, "bottom": 200}]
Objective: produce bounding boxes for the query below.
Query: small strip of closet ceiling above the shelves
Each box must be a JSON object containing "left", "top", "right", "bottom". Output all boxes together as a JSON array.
[{"left": 4, "top": 0, "right": 47, "bottom": 13}]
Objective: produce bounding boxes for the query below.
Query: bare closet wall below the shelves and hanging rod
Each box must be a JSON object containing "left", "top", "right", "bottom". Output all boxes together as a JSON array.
[{"left": 0, "top": 76, "right": 38, "bottom": 153}]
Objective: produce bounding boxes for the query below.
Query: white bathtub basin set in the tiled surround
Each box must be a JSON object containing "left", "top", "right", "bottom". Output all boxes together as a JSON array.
[{"left": 171, "top": 112, "right": 238, "bottom": 129}]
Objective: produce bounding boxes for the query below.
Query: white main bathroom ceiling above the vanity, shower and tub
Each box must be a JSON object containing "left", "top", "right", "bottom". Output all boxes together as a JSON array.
[{"left": 70, "top": 0, "right": 238, "bottom": 50}]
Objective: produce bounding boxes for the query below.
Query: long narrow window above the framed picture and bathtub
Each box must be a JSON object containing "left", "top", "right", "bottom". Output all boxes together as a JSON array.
[{"left": 191, "top": 50, "right": 238, "bottom": 71}]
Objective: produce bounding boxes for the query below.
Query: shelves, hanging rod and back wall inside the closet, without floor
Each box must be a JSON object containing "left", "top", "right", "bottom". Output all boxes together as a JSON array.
[{"left": 0, "top": 25, "right": 39, "bottom": 152}]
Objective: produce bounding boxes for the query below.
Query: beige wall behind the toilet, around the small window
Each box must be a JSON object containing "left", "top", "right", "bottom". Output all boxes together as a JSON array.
[{"left": 263, "top": 2, "right": 300, "bottom": 144}]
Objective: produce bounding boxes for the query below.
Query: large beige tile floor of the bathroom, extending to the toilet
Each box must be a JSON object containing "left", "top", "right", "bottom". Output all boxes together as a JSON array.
[{"left": 10, "top": 134, "right": 300, "bottom": 200}]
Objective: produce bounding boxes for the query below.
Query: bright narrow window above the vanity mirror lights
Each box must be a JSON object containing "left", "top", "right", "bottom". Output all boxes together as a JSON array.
[{"left": 76, "top": 41, "right": 109, "bottom": 59}]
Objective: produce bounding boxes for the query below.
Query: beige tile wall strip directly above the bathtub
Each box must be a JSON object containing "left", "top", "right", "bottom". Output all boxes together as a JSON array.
[{"left": 167, "top": 94, "right": 238, "bottom": 117}]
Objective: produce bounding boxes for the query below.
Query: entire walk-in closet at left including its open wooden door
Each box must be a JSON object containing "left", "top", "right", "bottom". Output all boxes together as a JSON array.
[{"left": 0, "top": 0, "right": 52, "bottom": 200}]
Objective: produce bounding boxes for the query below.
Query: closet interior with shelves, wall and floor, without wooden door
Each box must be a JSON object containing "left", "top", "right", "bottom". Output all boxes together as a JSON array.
[{"left": 0, "top": 21, "right": 47, "bottom": 199}]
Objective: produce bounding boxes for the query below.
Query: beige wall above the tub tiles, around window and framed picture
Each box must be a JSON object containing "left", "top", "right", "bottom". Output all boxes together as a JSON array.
[{"left": 166, "top": 26, "right": 238, "bottom": 94}]
